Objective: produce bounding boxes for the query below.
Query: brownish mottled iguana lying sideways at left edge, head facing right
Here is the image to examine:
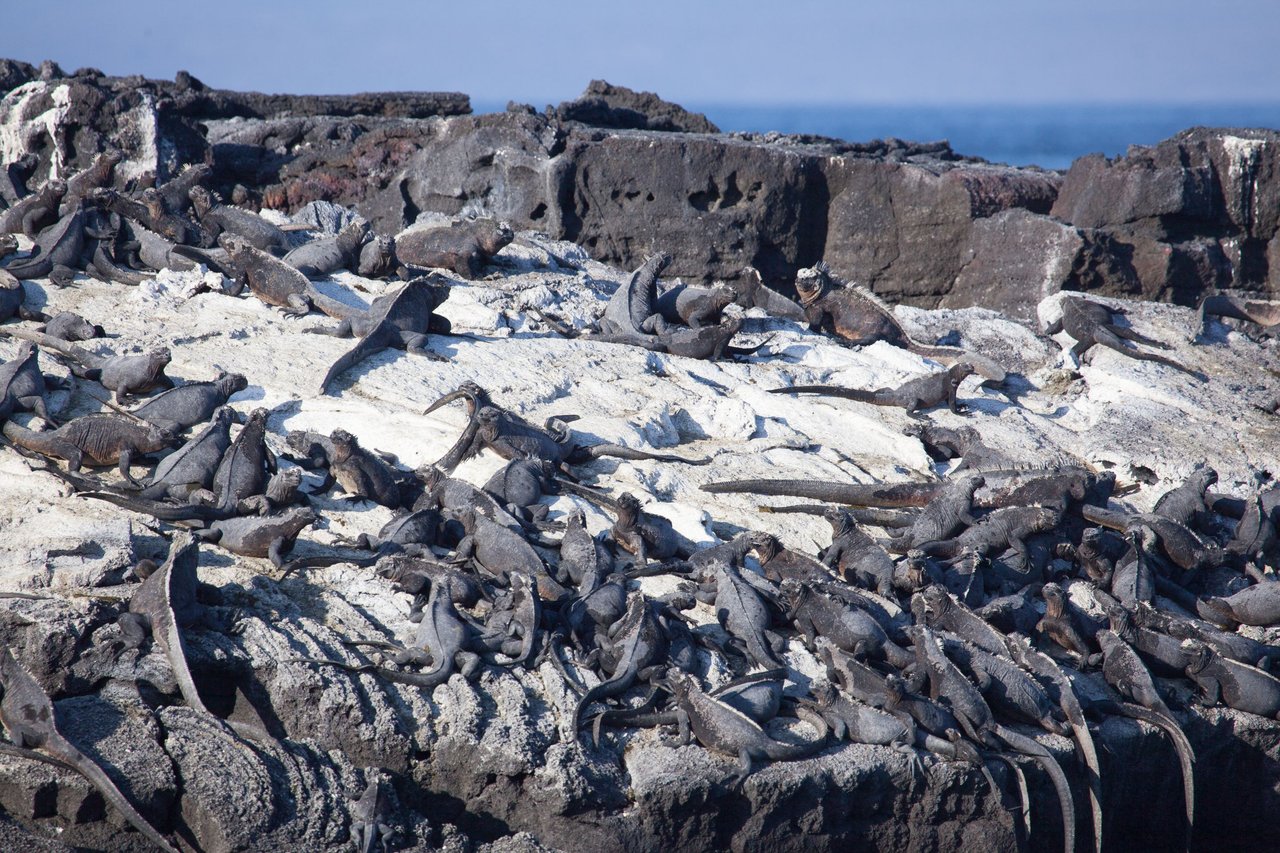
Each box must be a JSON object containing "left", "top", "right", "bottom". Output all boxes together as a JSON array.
[{"left": 4, "top": 415, "right": 177, "bottom": 485}]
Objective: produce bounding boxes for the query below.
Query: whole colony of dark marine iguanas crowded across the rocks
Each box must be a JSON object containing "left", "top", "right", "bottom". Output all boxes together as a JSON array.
[{"left": 0, "top": 155, "right": 1280, "bottom": 849}]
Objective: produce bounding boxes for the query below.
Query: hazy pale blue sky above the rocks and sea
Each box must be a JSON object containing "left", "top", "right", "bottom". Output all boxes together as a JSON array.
[{"left": 0, "top": 0, "right": 1280, "bottom": 109}]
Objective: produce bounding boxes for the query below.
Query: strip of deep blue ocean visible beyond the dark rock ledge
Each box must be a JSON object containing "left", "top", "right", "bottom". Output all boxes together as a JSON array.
[{"left": 472, "top": 99, "right": 1280, "bottom": 169}]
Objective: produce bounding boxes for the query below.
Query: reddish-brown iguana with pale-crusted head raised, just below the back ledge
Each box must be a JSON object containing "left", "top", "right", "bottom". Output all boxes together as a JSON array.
[{"left": 796, "top": 261, "right": 1005, "bottom": 382}]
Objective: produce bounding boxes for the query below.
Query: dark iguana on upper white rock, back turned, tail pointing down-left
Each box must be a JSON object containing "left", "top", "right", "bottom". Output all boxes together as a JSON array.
[{"left": 311, "top": 277, "right": 452, "bottom": 392}]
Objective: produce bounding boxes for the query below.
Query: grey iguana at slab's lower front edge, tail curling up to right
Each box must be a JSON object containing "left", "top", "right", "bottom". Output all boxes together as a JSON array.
[{"left": 664, "top": 670, "right": 827, "bottom": 783}]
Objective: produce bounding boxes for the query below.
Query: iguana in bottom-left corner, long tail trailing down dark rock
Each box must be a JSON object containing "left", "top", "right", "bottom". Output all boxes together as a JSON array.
[{"left": 0, "top": 646, "right": 178, "bottom": 853}]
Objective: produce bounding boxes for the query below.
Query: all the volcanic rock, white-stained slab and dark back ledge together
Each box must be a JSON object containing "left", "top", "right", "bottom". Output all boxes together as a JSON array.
[{"left": 0, "top": 63, "right": 1280, "bottom": 852}]
